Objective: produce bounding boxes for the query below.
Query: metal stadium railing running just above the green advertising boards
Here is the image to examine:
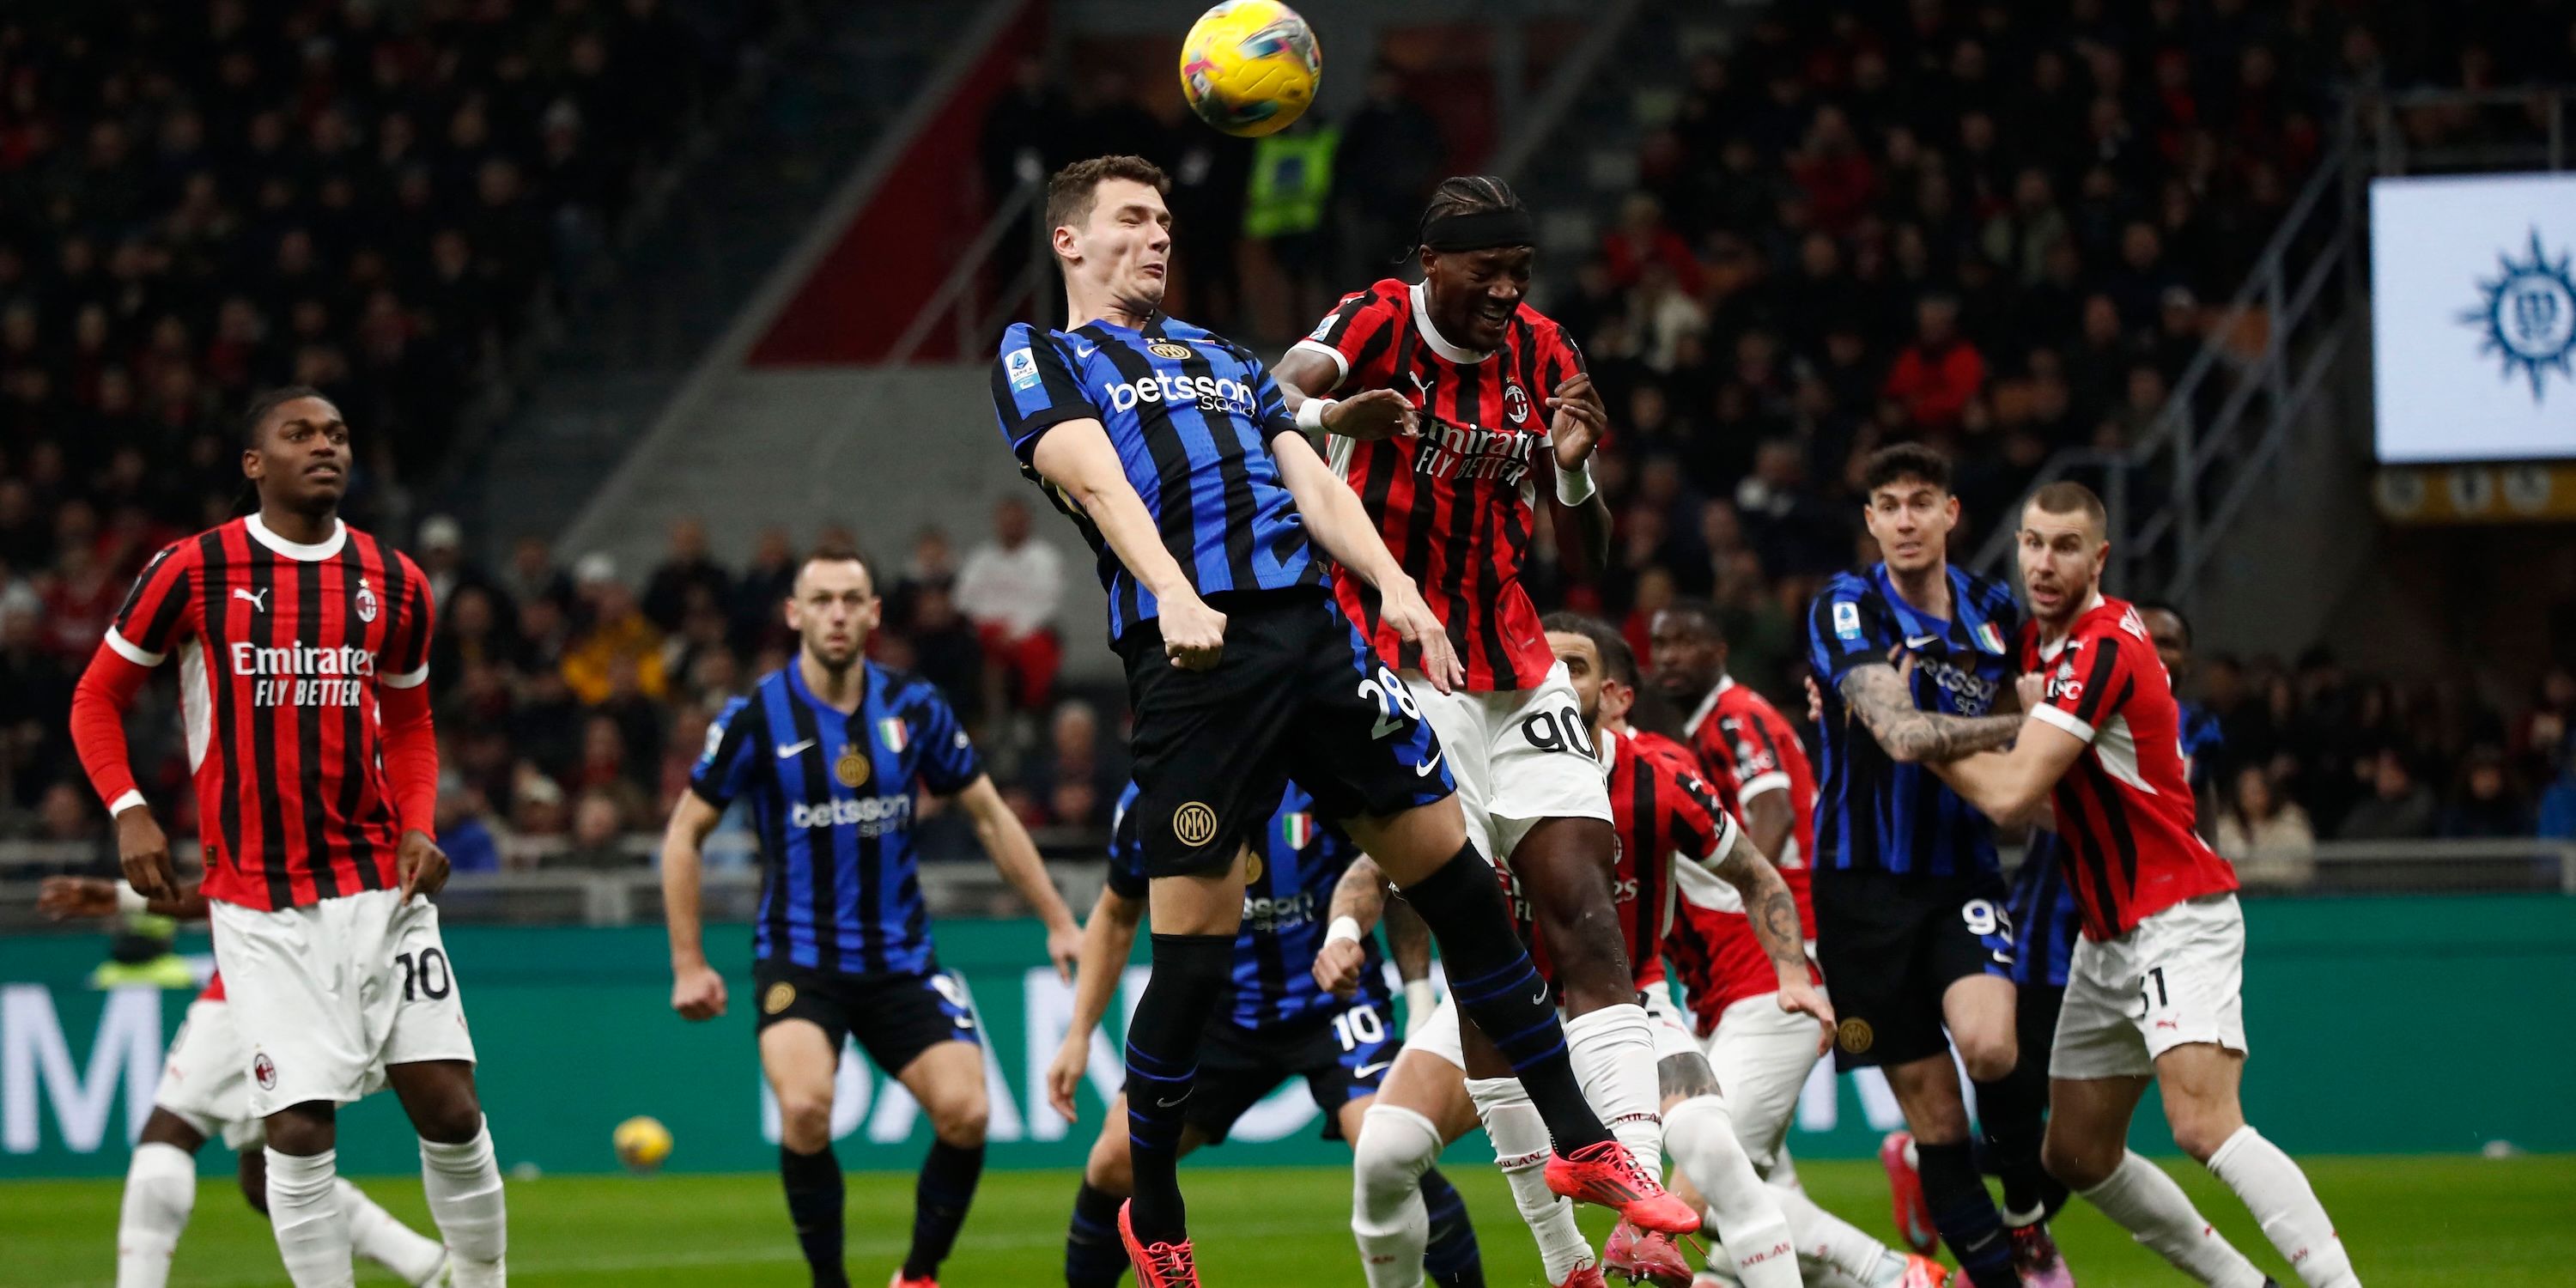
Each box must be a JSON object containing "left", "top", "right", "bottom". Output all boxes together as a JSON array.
[{"left": 0, "top": 829, "right": 2576, "bottom": 933}]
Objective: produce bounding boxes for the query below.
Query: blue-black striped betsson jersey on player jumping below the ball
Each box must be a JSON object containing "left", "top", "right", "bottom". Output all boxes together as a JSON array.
[{"left": 992, "top": 314, "right": 1324, "bottom": 639}]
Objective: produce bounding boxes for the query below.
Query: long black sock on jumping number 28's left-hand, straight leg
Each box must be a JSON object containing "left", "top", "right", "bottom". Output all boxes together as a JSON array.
[{"left": 1128, "top": 935, "right": 1234, "bottom": 1244}]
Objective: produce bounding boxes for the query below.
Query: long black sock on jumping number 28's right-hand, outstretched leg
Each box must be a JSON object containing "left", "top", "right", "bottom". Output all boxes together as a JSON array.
[{"left": 1404, "top": 845, "right": 1613, "bottom": 1154}]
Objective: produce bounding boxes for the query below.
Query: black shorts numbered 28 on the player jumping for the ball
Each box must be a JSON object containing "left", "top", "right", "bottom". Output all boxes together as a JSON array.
[{"left": 1118, "top": 587, "right": 1455, "bottom": 876}]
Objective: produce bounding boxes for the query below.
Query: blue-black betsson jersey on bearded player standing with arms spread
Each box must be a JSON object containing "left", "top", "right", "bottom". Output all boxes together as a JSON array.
[{"left": 688, "top": 662, "right": 984, "bottom": 974}]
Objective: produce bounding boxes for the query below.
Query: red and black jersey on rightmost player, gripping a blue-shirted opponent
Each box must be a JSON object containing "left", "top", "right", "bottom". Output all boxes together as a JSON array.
[{"left": 2022, "top": 595, "right": 2236, "bottom": 940}]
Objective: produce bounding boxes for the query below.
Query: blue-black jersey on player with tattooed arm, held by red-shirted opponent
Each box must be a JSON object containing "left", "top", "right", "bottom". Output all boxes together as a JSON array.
[{"left": 1806, "top": 564, "right": 2022, "bottom": 876}]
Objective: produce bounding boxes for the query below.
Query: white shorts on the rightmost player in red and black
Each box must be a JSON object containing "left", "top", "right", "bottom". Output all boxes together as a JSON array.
[{"left": 2048, "top": 894, "right": 2246, "bottom": 1079}]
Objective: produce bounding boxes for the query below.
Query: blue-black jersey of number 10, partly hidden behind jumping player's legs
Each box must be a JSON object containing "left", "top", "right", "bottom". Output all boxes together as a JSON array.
[{"left": 1110, "top": 783, "right": 1388, "bottom": 1030}]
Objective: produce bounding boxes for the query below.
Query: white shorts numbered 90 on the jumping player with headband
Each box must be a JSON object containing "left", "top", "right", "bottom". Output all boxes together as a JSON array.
[{"left": 1404, "top": 662, "right": 1610, "bottom": 866}]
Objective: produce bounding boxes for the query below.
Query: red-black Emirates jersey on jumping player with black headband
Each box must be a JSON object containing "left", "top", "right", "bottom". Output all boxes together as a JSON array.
[{"left": 1296, "top": 278, "right": 1584, "bottom": 693}]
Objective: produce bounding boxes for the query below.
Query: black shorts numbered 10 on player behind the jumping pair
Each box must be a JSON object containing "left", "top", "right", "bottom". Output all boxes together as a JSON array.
[{"left": 1182, "top": 994, "right": 1404, "bottom": 1144}]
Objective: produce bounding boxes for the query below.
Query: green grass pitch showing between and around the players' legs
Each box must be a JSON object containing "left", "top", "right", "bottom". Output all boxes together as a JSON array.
[{"left": 0, "top": 1151, "right": 2576, "bottom": 1288}]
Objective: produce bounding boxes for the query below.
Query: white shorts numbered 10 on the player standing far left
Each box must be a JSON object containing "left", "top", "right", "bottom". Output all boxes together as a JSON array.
[{"left": 209, "top": 889, "right": 474, "bottom": 1118}]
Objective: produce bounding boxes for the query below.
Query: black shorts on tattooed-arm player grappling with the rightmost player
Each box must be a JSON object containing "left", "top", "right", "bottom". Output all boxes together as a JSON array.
[{"left": 1808, "top": 868, "right": 2012, "bottom": 1069}]
